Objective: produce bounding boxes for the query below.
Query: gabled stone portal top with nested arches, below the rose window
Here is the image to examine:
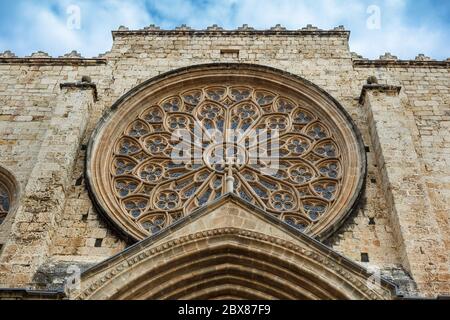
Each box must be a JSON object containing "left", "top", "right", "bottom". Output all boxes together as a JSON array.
[{"left": 74, "top": 195, "right": 396, "bottom": 300}]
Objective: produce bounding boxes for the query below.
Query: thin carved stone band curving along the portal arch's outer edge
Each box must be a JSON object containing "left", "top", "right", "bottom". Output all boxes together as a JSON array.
[{"left": 75, "top": 228, "right": 396, "bottom": 300}]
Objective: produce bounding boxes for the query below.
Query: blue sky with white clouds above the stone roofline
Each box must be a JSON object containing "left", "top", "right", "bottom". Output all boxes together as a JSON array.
[{"left": 0, "top": 0, "right": 450, "bottom": 60}]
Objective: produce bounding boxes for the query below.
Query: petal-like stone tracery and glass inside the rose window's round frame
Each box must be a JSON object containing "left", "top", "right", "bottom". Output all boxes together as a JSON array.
[{"left": 110, "top": 86, "right": 344, "bottom": 238}]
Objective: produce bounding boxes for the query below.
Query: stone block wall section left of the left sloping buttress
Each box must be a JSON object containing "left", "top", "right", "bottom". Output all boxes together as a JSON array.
[{"left": 0, "top": 59, "right": 105, "bottom": 248}]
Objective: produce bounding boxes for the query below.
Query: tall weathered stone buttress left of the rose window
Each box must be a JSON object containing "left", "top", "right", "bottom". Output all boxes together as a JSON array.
[{"left": 0, "top": 82, "right": 97, "bottom": 288}]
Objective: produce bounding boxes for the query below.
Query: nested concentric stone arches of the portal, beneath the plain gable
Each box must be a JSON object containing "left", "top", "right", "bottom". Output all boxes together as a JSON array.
[{"left": 80, "top": 229, "right": 391, "bottom": 300}]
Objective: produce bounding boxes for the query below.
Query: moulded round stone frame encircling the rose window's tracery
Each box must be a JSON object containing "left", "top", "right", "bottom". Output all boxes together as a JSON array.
[{"left": 86, "top": 63, "right": 367, "bottom": 242}]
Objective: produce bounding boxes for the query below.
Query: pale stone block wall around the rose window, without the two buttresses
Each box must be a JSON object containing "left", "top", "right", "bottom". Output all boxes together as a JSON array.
[{"left": 0, "top": 26, "right": 450, "bottom": 295}]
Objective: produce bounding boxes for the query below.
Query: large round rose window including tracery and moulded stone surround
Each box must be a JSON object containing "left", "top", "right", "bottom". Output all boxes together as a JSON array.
[{"left": 89, "top": 69, "right": 365, "bottom": 240}]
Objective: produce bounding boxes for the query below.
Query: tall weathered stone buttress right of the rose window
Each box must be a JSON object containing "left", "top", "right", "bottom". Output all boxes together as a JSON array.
[{"left": 360, "top": 84, "right": 449, "bottom": 296}]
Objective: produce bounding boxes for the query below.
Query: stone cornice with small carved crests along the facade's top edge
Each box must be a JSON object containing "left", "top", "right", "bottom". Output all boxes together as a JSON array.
[{"left": 0, "top": 24, "right": 450, "bottom": 68}]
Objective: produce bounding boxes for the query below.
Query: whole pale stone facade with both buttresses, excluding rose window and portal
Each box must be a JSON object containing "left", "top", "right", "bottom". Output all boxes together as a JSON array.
[{"left": 0, "top": 26, "right": 450, "bottom": 297}]
